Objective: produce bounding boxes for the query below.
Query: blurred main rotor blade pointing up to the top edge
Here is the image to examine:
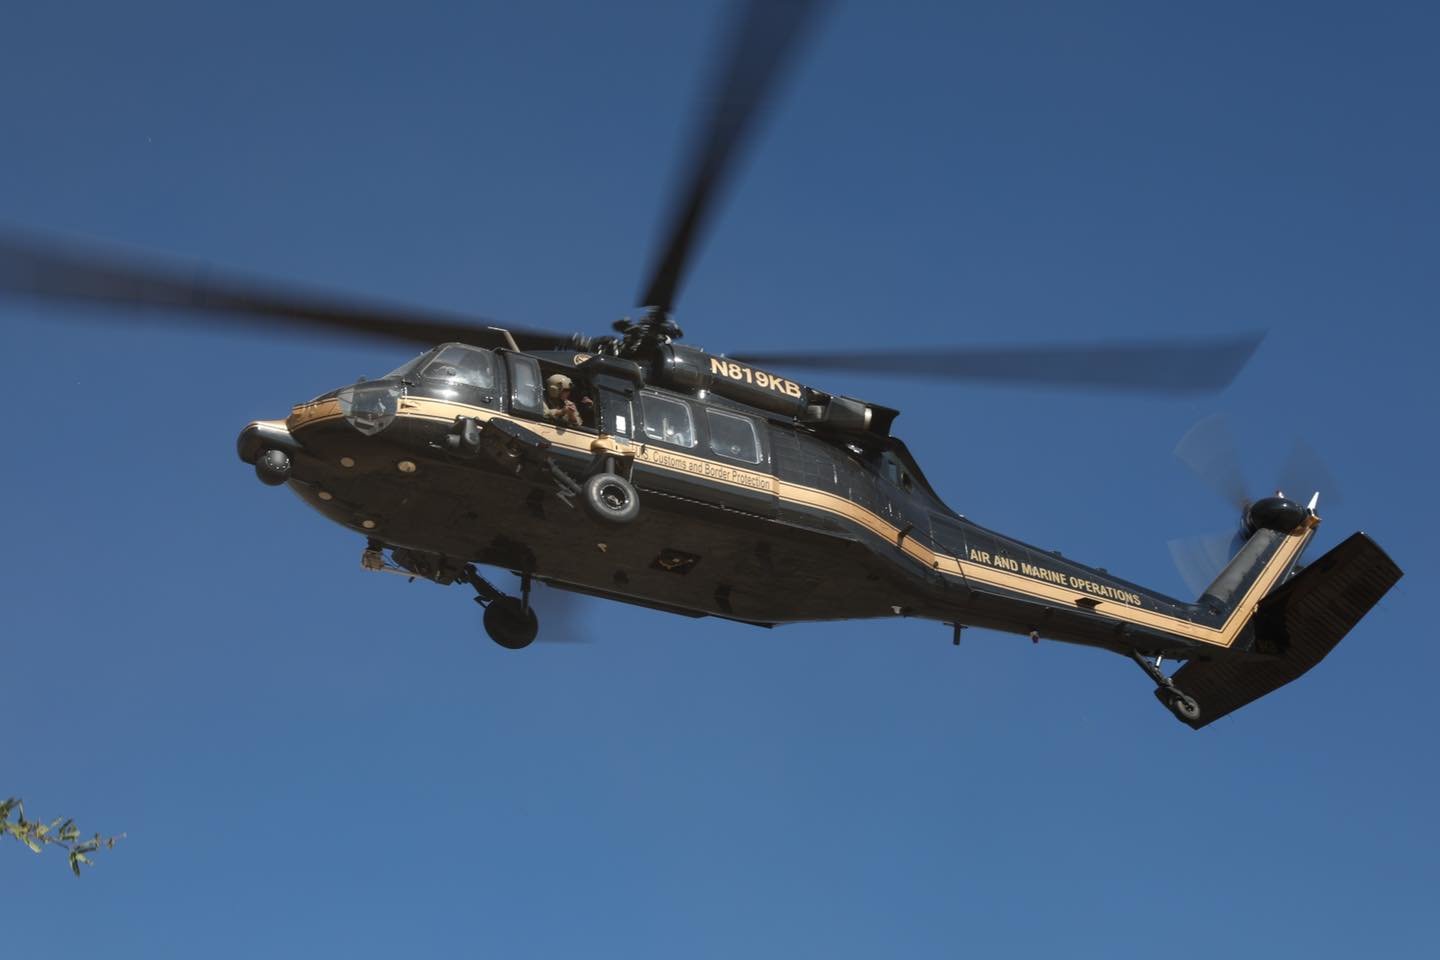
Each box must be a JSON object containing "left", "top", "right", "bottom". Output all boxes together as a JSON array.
[{"left": 639, "top": 0, "right": 828, "bottom": 314}]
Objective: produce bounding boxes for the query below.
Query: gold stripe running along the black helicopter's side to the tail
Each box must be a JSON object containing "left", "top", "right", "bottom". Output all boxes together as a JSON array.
[{"left": 285, "top": 397, "right": 1318, "bottom": 648}]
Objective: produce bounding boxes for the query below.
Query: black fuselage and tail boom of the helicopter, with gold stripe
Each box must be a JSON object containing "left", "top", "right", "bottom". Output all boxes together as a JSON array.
[{"left": 240, "top": 345, "right": 1313, "bottom": 658}]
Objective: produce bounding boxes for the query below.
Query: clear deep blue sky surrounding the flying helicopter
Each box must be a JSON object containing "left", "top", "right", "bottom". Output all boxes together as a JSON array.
[{"left": 0, "top": 1, "right": 1440, "bottom": 957}]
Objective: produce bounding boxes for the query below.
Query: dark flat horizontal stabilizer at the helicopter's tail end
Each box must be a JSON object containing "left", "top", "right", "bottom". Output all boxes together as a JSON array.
[{"left": 1158, "top": 534, "right": 1403, "bottom": 730}]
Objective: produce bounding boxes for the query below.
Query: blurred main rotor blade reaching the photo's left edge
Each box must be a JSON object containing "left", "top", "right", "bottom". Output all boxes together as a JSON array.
[{"left": 0, "top": 233, "right": 567, "bottom": 350}]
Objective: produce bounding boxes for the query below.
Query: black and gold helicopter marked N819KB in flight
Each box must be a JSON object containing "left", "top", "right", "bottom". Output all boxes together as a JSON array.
[{"left": 0, "top": 0, "right": 1401, "bottom": 728}]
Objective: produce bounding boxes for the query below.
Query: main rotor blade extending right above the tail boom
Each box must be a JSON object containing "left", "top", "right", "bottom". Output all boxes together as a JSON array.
[{"left": 734, "top": 334, "right": 1263, "bottom": 393}]
